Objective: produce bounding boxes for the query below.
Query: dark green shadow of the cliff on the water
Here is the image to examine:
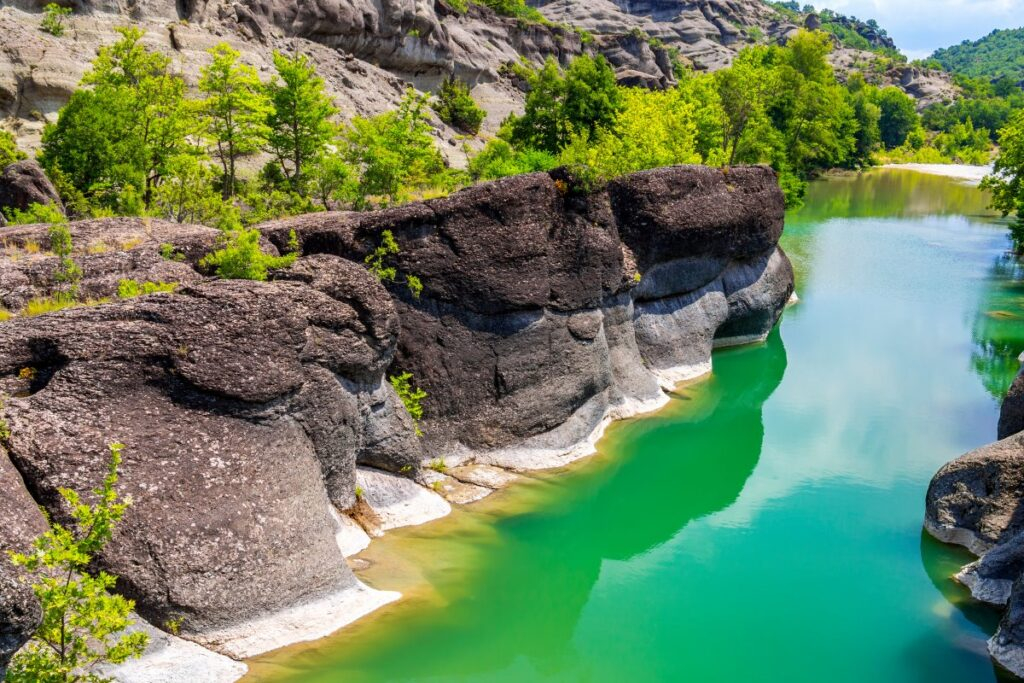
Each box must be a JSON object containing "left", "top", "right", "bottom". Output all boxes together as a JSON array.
[{"left": 260, "top": 331, "right": 786, "bottom": 681}]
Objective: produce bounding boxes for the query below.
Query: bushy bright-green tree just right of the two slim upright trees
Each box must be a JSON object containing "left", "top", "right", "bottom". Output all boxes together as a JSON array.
[{"left": 344, "top": 89, "right": 444, "bottom": 207}]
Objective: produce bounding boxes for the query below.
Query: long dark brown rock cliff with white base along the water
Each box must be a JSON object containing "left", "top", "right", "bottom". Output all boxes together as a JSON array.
[{"left": 0, "top": 167, "right": 793, "bottom": 679}]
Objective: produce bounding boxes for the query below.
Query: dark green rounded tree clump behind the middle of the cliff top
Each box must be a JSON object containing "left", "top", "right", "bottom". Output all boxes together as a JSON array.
[{"left": 503, "top": 55, "right": 622, "bottom": 155}]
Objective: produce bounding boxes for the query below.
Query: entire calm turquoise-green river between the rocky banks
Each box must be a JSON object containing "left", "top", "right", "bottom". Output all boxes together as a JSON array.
[{"left": 252, "top": 171, "right": 1024, "bottom": 683}]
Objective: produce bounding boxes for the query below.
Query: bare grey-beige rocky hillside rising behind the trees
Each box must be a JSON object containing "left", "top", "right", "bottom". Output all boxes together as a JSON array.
[{"left": 0, "top": 0, "right": 955, "bottom": 156}]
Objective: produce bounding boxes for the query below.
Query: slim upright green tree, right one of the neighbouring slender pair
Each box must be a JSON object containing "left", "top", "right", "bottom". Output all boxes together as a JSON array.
[{"left": 266, "top": 52, "right": 338, "bottom": 191}]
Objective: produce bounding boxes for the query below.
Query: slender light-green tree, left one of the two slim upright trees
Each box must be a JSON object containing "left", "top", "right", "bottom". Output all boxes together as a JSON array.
[{"left": 199, "top": 43, "right": 271, "bottom": 199}]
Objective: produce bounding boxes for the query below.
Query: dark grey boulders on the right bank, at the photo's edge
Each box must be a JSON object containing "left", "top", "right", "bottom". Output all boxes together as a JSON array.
[{"left": 925, "top": 372, "right": 1024, "bottom": 678}]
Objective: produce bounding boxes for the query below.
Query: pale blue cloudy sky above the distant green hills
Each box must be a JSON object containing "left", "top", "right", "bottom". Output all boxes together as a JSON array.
[{"left": 815, "top": 0, "right": 1024, "bottom": 59}]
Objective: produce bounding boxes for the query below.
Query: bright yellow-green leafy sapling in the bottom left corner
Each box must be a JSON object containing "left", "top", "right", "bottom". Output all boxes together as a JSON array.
[{"left": 6, "top": 443, "right": 148, "bottom": 683}]
